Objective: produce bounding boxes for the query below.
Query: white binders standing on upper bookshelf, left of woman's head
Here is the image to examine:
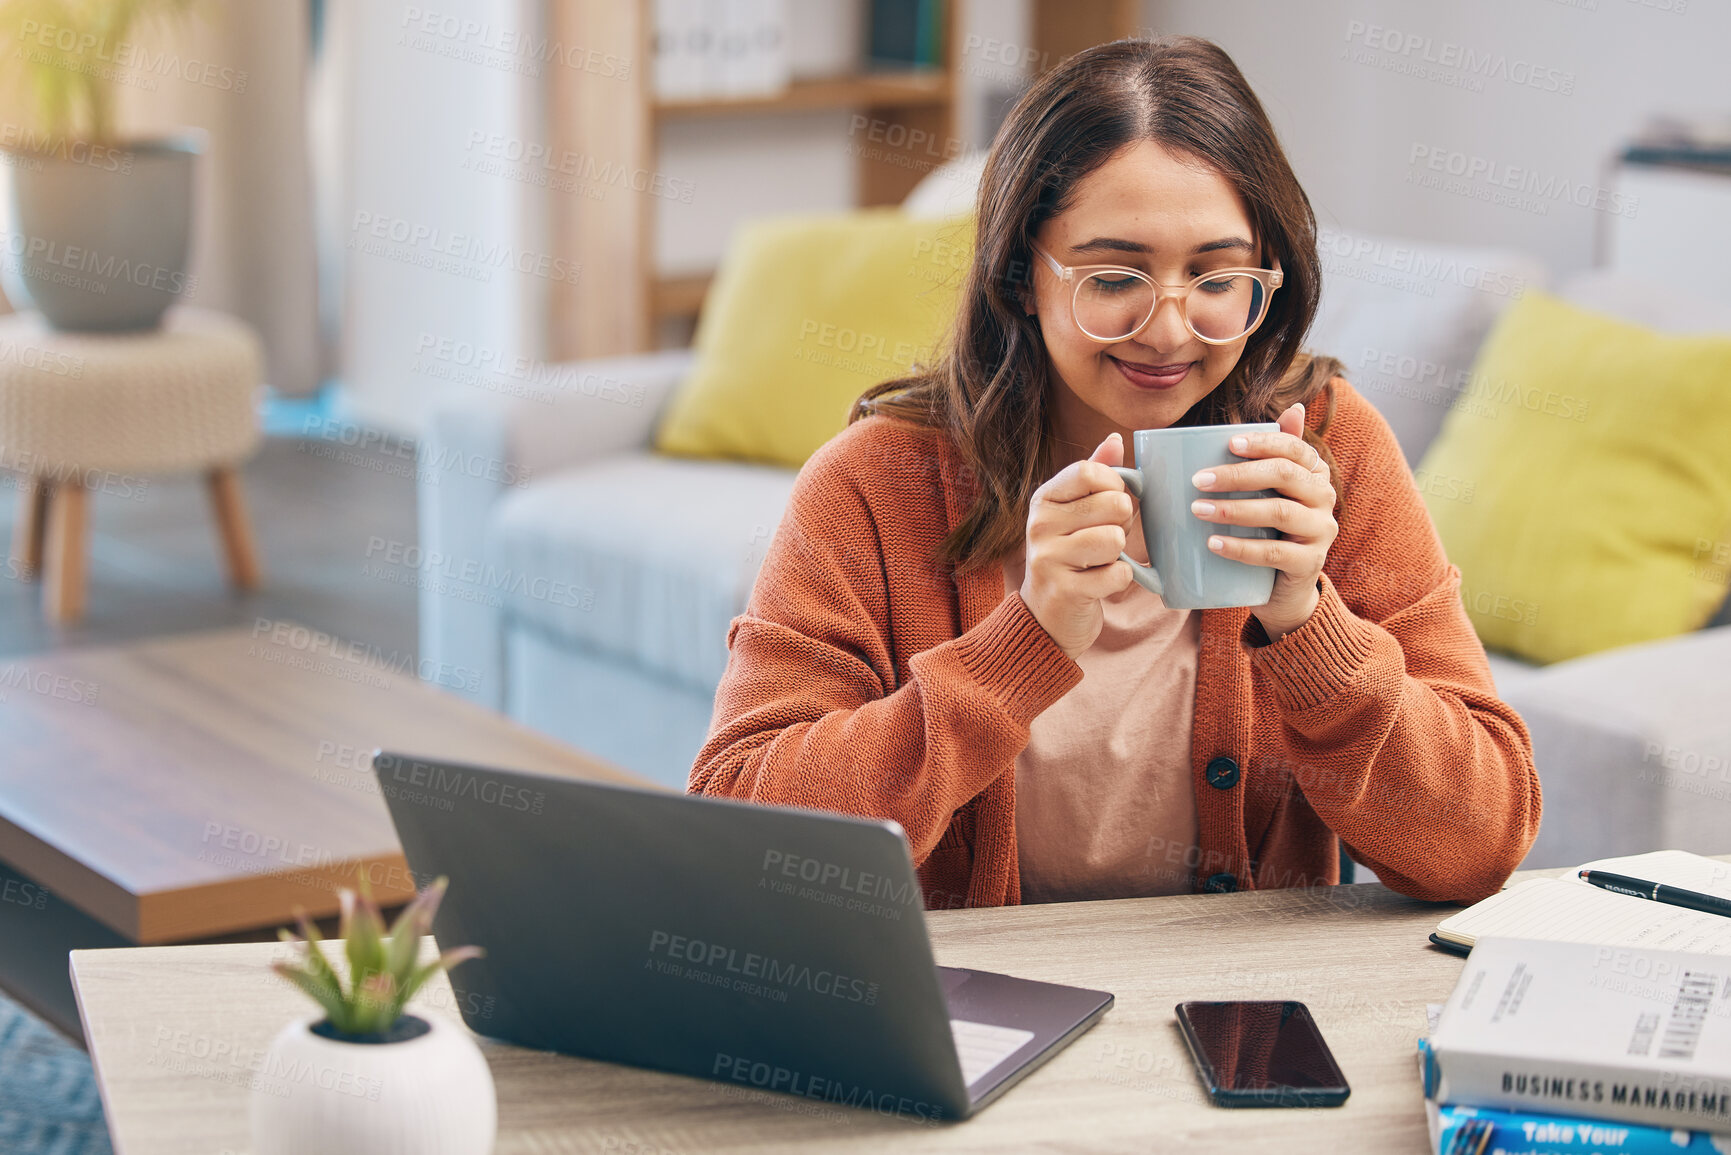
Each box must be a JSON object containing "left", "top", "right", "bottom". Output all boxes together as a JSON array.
[{"left": 654, "top": 0, "right": 791, "bottom": 100}]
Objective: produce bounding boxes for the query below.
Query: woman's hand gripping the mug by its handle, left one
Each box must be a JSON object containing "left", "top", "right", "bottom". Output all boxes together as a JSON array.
[{"left": 1021, "top": 433, "right": 1142, "bottom": 661}]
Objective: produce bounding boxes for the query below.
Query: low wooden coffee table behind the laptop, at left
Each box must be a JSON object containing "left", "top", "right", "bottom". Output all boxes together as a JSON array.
[{"left": 0, "top": 620, "right": 651, "bottom": 1039}]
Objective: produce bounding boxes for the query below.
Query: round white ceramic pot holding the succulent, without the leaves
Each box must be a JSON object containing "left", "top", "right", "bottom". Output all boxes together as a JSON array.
[{"left": 251, "top": 1015, "right": 499, "bottom": 1155}]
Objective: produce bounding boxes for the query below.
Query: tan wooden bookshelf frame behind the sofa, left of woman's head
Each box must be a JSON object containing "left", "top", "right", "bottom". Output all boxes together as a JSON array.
[{"left": 547, "top": 0, "right": 1136, "bottom": 360}]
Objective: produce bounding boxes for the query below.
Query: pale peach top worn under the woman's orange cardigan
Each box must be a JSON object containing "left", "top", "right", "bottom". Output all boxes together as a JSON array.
[{"left": 1004, "top": 532, "right": 1201, "bottom": 902}]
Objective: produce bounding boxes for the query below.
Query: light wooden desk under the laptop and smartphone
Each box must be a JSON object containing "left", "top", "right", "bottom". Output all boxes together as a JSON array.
[{"left": 73, "top": 871, "right": 1516, "bottom": 1155}]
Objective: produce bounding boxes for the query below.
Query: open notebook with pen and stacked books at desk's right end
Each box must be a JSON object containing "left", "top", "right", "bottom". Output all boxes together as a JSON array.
[{"left": 1419, "top": 850, "right": 1731, "bottom": 1155}]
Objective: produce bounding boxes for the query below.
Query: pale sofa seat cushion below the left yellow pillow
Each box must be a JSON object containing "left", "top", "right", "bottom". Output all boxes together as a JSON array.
[{"left": 486, "top": 452, "right": 796, "bottom": 693}]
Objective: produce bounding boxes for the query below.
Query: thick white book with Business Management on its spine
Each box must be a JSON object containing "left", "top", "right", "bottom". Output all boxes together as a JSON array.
[{"left": 1425, "top": 939, "right": 1731, "bottom": 1134}]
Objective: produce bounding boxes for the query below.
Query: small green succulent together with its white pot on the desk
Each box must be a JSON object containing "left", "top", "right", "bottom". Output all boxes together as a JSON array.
[{"left": 251, "top": 878, "right": 497, "bottom": 1155}]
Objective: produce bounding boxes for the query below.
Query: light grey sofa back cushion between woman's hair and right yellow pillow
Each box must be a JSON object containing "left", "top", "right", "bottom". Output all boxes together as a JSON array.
[{"left": 1307, "top": 229, "right": 1546, "bottom": 466}]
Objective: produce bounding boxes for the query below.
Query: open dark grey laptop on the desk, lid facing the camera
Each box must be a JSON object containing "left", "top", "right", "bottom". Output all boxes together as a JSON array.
[{"left": 372, "top": 750, "right": 1113, "bottom": 1122}]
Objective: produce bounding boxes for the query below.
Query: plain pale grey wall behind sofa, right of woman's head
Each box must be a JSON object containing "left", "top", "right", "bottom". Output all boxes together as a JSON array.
[{"left": 1144, "top": 0, "right": 1731, "bottom": 275}]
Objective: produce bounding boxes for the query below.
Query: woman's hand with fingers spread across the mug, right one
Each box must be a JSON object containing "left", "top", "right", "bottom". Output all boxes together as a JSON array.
[{"left": 1191, "top": 405, "right": 1340, "bottom": 642}]
